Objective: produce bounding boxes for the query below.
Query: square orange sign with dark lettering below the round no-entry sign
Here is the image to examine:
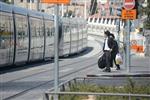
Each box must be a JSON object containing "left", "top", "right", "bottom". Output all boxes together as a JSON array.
[{"left": 121, "top": 9, "right": 137, "bottom": 20}]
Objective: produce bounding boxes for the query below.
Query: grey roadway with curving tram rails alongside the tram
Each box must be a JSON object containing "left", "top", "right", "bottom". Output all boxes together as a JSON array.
[{"left": 0, "top": 41, "right": 102, "bottom": 100}]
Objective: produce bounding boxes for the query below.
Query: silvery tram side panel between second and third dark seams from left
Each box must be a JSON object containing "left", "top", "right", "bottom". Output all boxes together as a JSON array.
[{"left": 29, "top": 17, "right": 44, "bottom": 61}]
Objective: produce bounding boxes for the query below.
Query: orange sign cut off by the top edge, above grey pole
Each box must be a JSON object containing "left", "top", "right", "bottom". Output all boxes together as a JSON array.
[{"left": 41, "top": 0, "right": 70, "bottom": 4}]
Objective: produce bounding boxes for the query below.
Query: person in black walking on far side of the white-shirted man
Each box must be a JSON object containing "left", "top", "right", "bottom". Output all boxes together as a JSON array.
[{"left": 109, "top": 34, "right": 120, "bottom": 70}]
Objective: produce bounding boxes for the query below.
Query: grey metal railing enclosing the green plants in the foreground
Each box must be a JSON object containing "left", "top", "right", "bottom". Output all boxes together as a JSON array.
[{"left": 43, "top": 76, "right": 150, "bottom": 100}]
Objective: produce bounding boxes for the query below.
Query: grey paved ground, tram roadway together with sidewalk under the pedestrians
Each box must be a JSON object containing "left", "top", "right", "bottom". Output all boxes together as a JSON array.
[{"left": 0, "top": 38, "right": 150, "bottom": 100}]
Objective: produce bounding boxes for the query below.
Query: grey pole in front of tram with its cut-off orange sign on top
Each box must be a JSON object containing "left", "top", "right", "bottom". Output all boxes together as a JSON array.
[{"left": 41, "top": 0, "right": 70, "bottom": 100}]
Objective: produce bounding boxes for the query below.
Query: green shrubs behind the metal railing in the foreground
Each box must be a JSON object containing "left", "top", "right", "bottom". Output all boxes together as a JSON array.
[{"left": 60, "top": 78, "right": 150, "bottom": 100}]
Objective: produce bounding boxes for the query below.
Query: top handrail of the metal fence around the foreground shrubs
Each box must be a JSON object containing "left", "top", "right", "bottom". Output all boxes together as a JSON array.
[{"left": 44, "top": 76, "right": 150, "bottom": 100}]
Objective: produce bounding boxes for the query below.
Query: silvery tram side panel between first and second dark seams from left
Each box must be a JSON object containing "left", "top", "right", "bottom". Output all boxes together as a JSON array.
[{"left": 15, "top": 14, "right": 29, "bottom": 63}]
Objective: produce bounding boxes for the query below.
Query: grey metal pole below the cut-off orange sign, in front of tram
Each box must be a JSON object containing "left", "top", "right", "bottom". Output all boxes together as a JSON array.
[{"left": 54, "top": 4, "right": 59, "bottom": 100}]
